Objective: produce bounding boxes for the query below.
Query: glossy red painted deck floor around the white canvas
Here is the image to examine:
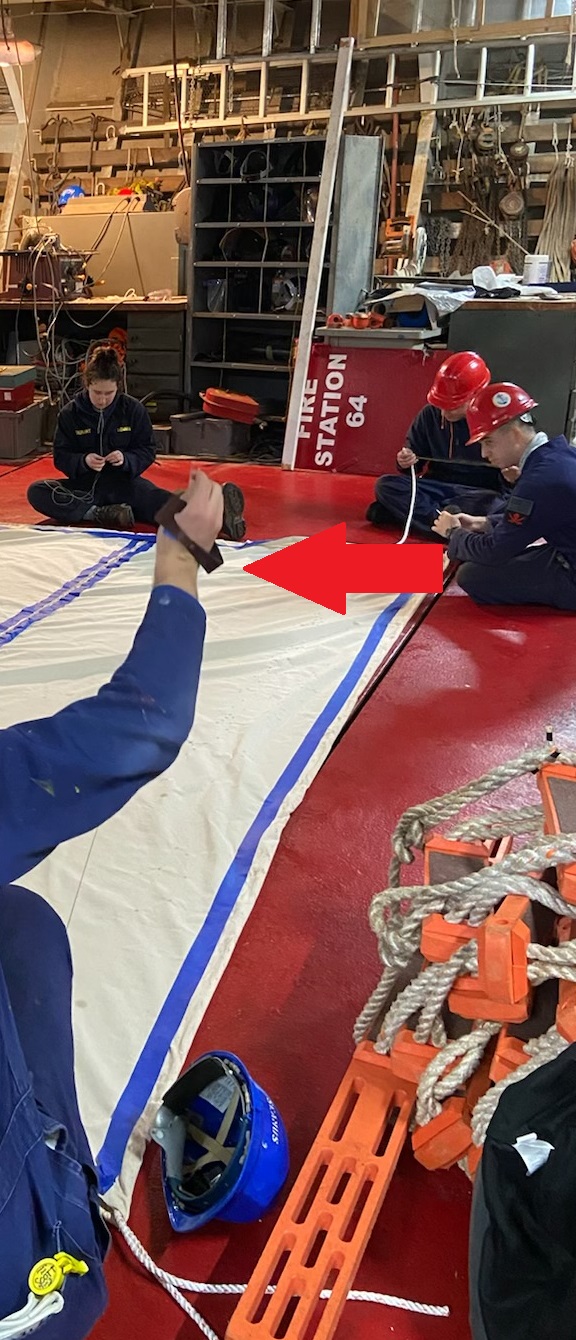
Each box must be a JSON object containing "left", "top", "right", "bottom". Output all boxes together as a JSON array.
[{"left": 0, "top": 462, "right": 576, "bottom": 1340}]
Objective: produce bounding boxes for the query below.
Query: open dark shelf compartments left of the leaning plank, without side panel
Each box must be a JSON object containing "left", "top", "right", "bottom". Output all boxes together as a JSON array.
[{"left": 189, "top": 135, "right": 330, "bottom": 415}]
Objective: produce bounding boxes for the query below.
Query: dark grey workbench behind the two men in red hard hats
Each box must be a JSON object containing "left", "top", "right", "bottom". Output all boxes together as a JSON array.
[{"left": 449, "top": 295, "right": 576, "bottom": 440}]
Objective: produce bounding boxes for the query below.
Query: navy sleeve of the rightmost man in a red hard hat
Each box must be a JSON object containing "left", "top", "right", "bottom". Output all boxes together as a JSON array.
[{"left": 447, "top": 482, "right": 551, "bottom": 567}]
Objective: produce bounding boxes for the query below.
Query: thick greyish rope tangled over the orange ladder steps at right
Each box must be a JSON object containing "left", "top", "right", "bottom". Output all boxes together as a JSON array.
[{"left": 355, "top": 745, "right": 576, "bottom": 1163}]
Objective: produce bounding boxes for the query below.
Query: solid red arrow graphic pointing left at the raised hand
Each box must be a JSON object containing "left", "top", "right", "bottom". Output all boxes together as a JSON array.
[{"left": 244, "top": 521, "right": 443, "bottom": 614}]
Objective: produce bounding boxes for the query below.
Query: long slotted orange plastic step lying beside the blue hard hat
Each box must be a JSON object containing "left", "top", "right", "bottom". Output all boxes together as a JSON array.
[{"left": 226, "top": 1043, "right": 415, "bottom": 1340}]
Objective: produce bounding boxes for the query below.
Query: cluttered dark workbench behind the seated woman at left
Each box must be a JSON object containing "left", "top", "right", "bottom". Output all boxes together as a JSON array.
[{"left": 0, "top": 297, "right": 186, "bottom": 419}]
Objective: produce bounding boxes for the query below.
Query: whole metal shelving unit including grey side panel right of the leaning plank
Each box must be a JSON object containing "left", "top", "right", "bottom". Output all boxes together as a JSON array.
[{"left": 185, "top": 135, "right": 382, "bottom": 418}]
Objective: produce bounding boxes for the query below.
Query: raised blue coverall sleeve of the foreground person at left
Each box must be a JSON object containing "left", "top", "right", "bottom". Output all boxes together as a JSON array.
[{"left": 0, "top": 586, "right": 206, "bottom": 884}]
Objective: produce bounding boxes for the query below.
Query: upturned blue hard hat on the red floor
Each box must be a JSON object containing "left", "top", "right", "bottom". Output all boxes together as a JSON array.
[{"left": 151, "top": 1052, "right": 289, "bottom": 1233}]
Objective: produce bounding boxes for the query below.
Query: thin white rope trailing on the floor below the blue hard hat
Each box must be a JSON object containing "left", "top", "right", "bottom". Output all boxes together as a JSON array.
[{"left": 106, "top": 1210, "right": 450, "bottom": 1340}]
